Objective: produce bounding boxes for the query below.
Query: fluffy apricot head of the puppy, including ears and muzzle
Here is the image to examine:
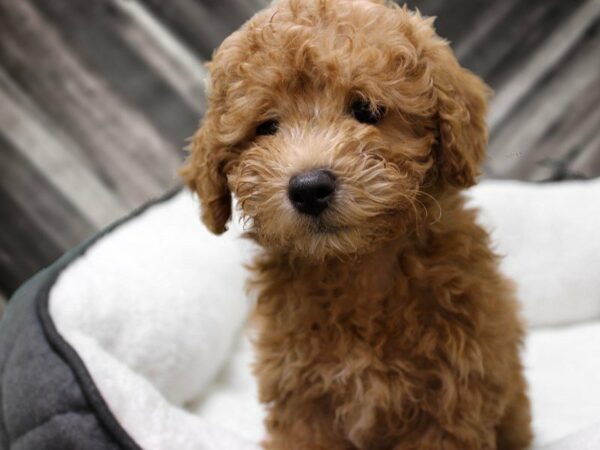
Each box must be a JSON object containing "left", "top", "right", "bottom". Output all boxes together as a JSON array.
[{"left": 182, "top": 0, "right": 487, "bottom": 257}]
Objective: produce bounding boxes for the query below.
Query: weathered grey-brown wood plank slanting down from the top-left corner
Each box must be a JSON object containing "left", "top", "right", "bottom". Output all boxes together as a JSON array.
[{"left": 0, "top": 1, "right": 185, "bottom": 201}]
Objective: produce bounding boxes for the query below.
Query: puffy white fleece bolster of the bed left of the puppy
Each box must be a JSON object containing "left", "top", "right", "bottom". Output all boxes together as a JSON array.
[{"left": 50, "top": 192, "right": 251, "bottom": 405}]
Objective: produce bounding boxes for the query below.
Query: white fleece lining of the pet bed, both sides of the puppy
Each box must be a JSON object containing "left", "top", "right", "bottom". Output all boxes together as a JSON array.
[{"left": 49, "top": 181, "right": 600, "bottom": 450}]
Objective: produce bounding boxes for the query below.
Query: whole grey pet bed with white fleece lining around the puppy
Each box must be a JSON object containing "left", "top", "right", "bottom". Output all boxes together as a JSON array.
[{"left": 0, "top": 180, "right": 600, "bottom": 450}]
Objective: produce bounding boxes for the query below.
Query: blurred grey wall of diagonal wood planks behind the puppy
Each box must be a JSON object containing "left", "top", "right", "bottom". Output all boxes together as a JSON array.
[{"left": 0, "top": 0, "right": 600, "bottom": 309}]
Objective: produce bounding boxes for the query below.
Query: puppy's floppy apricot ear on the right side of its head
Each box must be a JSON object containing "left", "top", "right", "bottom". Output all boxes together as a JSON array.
[{"left": 430, "top": 40, "right": 491, "bottom": 188}]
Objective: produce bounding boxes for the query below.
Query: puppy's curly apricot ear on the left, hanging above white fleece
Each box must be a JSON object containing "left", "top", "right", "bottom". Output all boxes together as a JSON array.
[{"left": 179, "top": 121, "right": 231, "bottom": 234}]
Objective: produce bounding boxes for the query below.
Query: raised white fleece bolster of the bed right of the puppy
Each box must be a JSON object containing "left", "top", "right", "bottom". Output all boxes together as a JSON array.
[{"left": 469, "top": 179, "right": 600, "bottom": 327}]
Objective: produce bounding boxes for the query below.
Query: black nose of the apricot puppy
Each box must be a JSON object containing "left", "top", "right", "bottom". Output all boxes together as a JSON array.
[{"left": 288, "top": 169, "right": 335, "bottom": 217}]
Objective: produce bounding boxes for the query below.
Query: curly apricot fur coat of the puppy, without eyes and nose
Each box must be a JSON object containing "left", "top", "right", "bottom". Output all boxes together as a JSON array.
[{"left": 182, "top": 0, "right": 531, "bottom": 450}]
